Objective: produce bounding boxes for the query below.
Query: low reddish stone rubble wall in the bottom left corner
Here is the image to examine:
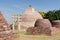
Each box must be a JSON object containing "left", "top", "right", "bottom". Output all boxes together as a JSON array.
[{"left": 0, "top": 30, "right": 19, "bottom": 40}]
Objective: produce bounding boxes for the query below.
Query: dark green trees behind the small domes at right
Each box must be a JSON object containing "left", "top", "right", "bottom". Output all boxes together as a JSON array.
[{"left": 44, "top": 10, "right": 60, "bottom": 22}]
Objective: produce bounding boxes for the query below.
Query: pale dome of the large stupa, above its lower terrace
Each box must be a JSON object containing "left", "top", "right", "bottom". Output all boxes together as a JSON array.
[{"left": 21, "top": 6, "right": 43, "bottom": 22}]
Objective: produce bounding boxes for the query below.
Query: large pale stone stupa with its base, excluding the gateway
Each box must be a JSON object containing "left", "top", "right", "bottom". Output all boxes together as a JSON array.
[{"left": 20, "top": 5, "right": 43, "bottom": 30}]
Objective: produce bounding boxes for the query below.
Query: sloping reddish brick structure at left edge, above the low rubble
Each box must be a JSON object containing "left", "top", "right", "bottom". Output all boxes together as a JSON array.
[{"left": 0, "top": 12, "right": 10, "bottom": 31}]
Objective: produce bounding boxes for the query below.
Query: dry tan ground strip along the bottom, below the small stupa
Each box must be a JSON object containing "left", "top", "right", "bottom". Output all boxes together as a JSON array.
[{"left": 14, "top": 35, "right": 60, "bottom": 40}]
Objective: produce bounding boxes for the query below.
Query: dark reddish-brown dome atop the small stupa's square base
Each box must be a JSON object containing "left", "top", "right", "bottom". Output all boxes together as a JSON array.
[{"left": 35, "top": 19, "right": 52, "bottom": 27}]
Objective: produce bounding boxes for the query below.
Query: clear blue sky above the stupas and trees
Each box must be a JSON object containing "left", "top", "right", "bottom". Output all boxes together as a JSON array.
[{"left": 0, "top": 0, "right": 60, "bottom": 24}]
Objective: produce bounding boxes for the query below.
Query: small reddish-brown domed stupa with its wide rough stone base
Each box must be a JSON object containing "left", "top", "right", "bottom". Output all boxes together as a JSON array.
[{"left": 26, "top": 19, "right": 57, "bottom": 35}]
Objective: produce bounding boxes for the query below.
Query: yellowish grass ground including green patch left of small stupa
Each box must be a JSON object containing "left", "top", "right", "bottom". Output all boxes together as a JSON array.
[{"left": 14, "top": 30, "right": 60, "bottom": 40}]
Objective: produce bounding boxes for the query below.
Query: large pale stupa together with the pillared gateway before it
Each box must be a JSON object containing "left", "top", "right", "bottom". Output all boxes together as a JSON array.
[{"left": 12, "top": 6, "right": 43, "bottom": 30}]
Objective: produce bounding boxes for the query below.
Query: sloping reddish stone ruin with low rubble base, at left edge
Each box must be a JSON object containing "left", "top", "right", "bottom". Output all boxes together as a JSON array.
[{"left": 0, "top": 12, "right": 18, "bottom": 40}]
